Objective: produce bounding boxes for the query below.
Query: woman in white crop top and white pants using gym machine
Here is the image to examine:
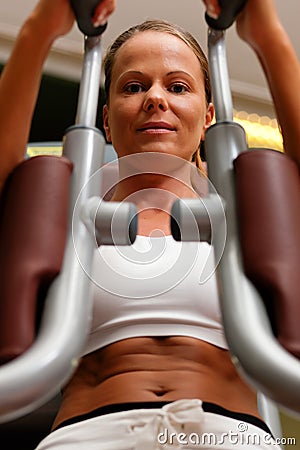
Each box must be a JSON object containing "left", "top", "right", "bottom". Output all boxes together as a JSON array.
[{"left": 0, "top": 0, "right": 300, "bottom": 450}]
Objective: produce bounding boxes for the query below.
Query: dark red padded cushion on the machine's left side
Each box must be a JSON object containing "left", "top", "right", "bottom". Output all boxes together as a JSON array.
[{"left": 0, "top": 156, "right": 72, "bottom": 364}]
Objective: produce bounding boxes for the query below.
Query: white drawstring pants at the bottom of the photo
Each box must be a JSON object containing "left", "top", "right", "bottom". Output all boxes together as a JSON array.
[{"left": 36, "top": 400, "right": 280, "bottom": 450}]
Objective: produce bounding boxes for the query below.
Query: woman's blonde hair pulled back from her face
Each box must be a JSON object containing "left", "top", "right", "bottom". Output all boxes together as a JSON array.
[{"left": 104, "top": 20, "right": 212, "bottom": 174}]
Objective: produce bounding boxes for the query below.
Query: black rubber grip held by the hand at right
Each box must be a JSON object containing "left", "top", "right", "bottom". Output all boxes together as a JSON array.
[{"left": 205, "top": 0, "right": 247, "bottom": 30}]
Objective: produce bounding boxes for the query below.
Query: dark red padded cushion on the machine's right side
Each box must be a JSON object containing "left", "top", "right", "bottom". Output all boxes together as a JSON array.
[{"left": 234, "top": 149, "right": 300, "bottom": 358}]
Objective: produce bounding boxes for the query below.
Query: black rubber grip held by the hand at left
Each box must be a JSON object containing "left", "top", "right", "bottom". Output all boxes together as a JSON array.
[{"left": 70, "top": 0, "right": 107, "bottom": 36}]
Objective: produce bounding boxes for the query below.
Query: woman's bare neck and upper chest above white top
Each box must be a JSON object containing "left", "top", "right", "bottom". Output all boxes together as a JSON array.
[{"left": 111, "top": 154, "right": 198, "bottom": 235}]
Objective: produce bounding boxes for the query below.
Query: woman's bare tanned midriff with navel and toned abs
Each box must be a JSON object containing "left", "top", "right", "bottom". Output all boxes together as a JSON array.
[{"left": 53, "top": 336, "right": 259, "bottom": 428}]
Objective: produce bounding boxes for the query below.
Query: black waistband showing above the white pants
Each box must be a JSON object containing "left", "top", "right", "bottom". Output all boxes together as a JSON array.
[{"left": 52, "top": 401, "right": 272, "bottom": 436}]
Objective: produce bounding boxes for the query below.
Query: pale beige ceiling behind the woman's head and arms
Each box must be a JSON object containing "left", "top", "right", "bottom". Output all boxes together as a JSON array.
[{"left": 0, "top": 0, "right": 300, "bottom": 116}]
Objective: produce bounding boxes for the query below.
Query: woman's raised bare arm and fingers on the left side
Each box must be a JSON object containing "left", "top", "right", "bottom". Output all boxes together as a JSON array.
[{"left": 0, "top": 0, "right": 114, "bottom": 190}]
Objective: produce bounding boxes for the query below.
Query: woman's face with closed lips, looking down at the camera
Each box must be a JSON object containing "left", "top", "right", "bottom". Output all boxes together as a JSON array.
[{"left": 104, "top": 31, "right": 213, "bottom": 161}]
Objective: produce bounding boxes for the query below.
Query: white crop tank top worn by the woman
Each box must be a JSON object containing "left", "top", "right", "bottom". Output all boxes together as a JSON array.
[{"left": 84, "top": 235, "right": 228, "bottom": 354}]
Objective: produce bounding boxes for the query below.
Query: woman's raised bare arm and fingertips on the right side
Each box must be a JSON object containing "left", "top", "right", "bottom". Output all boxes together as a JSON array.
[{"left": 203, "top": 0, "right": 300, "bottom": 165}]
